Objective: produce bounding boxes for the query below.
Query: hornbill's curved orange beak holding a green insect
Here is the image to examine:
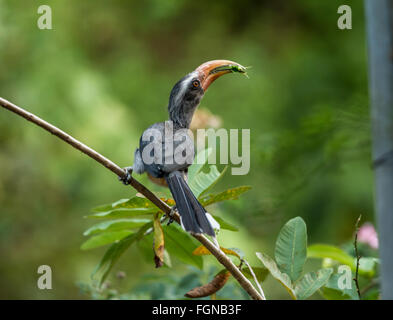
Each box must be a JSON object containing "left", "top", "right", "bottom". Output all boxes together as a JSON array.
[{"left": 195, "top": 60, "right": 246, "bottom": 91}]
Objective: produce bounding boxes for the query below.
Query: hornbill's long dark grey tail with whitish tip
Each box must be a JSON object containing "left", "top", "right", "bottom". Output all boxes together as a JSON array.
[{"left": 166, "top": 171, "right": 215, "bottom": 237}]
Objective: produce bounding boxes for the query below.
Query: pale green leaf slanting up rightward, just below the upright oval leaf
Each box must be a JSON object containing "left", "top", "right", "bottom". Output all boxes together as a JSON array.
[{"left": 295, "top": 268, "right": 333, "bottom": 300}]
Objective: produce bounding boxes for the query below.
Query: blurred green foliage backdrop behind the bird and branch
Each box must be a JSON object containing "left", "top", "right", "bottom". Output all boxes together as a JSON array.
[{"left": 0, "top": 0, "right": 374, "bottom": 299}]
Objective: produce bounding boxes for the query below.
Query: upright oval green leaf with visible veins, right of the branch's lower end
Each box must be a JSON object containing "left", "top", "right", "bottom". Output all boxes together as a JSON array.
[{"left": 274, "top": 217, "right": 307, "bottom": 281}]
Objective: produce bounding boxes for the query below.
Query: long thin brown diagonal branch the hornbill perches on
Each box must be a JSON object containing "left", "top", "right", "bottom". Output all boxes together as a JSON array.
[{"left": 0, "top": 98, "right": 264, "bottom": 300}]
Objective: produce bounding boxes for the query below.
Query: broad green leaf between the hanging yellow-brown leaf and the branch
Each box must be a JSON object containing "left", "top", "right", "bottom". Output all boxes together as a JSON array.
[{"left": 164, "top": 225, "right": 203, "bottom": 269}]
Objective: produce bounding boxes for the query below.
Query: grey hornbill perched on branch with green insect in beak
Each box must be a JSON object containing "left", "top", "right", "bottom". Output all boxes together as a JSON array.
[{"left": 121, "top": 60, "right": 246, "bottom": 237}]
